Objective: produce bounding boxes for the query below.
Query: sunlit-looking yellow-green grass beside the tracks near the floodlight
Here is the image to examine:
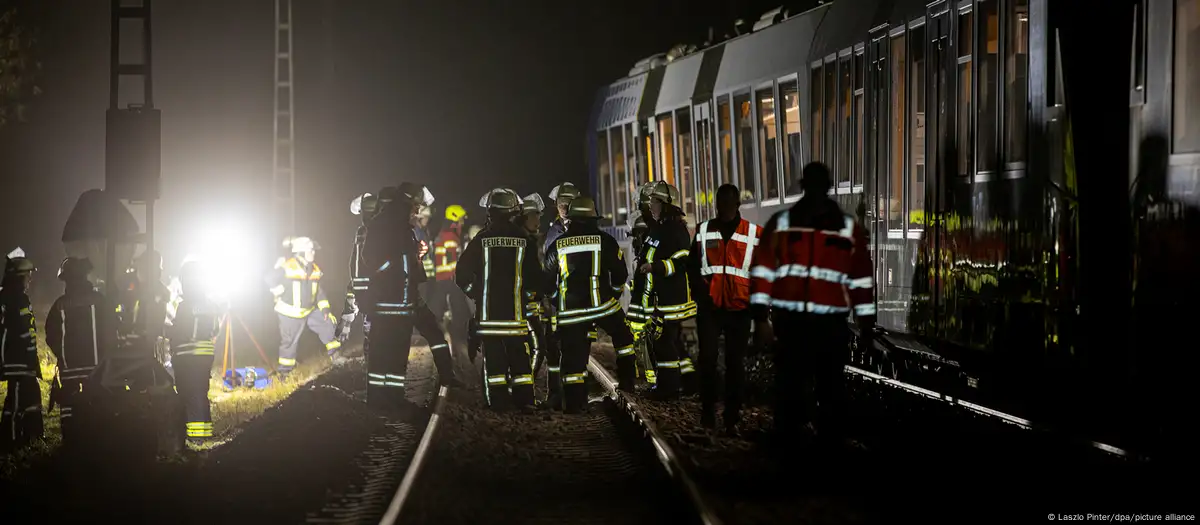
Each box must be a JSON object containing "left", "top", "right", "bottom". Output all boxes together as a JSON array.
[{"left": 0, "top": 320, "right": 330, "bottom": 469}]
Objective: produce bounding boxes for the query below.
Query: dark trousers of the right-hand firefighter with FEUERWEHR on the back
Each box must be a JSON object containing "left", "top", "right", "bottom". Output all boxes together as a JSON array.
[{"left": 558, "top": 310, "right": 637, "bottom": 412}]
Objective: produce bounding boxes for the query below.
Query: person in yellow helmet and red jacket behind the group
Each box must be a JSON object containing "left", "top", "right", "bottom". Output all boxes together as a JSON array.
[{"left": 428, "top": 204, "right": 470, "bottom": 349}]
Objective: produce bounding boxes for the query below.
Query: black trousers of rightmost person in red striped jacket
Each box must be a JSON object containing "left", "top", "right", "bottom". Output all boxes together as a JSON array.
[{"left": 773, "top": 312, "right": 850, "bottom": 441}]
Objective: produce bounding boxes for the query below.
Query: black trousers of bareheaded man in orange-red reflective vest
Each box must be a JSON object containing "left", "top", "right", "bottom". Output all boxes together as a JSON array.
[{"left": 696, "top": 309, "right": 751, "bottom": 426}]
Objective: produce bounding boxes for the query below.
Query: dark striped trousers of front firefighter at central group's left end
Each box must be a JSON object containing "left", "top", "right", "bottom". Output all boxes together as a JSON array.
[{"left": 367, "top": 313, "right": 415, "bottom": 408}]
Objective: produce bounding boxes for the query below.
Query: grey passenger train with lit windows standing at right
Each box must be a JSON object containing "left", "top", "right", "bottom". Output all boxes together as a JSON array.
[{"left": 589, "top": 0, "right": 1200, "bottom": 460}]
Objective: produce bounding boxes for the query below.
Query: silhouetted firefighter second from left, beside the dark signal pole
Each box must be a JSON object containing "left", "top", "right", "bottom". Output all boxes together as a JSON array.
[{"left": 46, "top": 258, "right": 119, "bottom": 443}]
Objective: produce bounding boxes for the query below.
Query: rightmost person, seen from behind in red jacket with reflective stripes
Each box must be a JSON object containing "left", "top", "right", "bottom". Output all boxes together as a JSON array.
[{"left": 750, "top": 162, "right": 875, "bottom": 445}]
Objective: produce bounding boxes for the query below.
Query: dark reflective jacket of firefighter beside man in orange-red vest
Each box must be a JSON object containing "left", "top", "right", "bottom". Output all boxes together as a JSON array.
[{"left": 629, "top": 216, "right": 707, "bottom": 322}]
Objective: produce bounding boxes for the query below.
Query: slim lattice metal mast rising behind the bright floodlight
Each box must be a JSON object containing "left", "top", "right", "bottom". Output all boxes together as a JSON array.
[{"left": 272, "top": 0, "right": 296, "bottom": 239}]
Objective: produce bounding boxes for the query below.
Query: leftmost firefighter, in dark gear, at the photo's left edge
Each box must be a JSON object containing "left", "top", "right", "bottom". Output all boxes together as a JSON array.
[{"left": 0, "top": 248, "right": 43, "bottom": 449}]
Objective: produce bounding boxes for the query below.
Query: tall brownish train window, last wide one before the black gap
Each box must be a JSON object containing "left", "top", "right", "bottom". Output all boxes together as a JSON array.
[{"left": 1004, "top": 0, "right": 1030, "bottom": 164}]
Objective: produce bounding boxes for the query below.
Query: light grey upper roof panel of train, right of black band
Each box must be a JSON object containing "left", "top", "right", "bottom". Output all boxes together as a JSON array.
[{"left": 713, "top": 2, "right": 830, "bottom": 93}]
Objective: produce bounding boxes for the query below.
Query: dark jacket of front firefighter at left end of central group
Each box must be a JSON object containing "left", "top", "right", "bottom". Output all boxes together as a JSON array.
[{"left": 361, "top": 209, "right": 426, "bottom": 315}]
